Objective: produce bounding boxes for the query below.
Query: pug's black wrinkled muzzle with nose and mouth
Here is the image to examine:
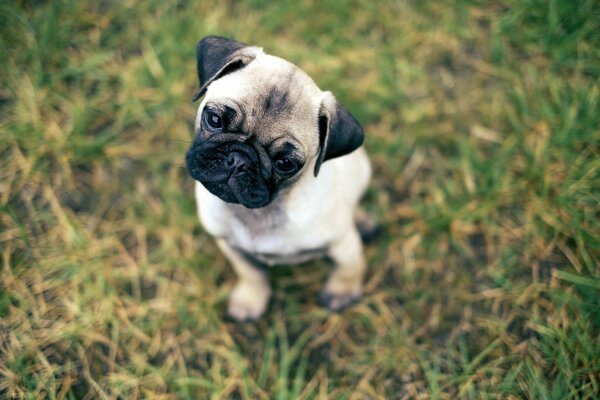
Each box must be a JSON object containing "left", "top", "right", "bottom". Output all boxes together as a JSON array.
[{"left": 185, "top": 145, "right": 274, "bottom": 208}]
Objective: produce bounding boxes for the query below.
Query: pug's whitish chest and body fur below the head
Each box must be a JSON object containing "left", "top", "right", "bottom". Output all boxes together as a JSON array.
[{"left": 196, "top": 148, "right": 370, "bottom": 264}]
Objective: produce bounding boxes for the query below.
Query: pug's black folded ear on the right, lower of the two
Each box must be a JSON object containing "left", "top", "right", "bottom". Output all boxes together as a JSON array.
[{"left": 315, "top": 92, "right": 365, "bottom": 176}]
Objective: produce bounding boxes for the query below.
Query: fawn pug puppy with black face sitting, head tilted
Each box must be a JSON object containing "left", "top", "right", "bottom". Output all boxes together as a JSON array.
[{"left": 185, "top": 36, "right": 374, "bottom": 321}]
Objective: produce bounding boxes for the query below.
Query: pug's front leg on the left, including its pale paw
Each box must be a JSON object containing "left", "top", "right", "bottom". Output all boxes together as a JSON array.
[{"left": 217, "top": 239, "right": 271, "bottom": 321}]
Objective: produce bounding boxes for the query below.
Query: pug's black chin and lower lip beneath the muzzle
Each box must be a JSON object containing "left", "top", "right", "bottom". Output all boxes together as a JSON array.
[{"left": 200, "top": 178, "right": 273, "bottom": 208}]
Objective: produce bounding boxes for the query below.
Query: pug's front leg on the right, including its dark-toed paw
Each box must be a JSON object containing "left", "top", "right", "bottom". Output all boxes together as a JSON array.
[{"left": 319, "top": 229, "right": 366, "bottom": 311}]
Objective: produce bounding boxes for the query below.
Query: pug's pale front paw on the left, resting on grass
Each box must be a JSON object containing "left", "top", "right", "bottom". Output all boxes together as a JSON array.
[{"left": 227, "top": 282, "right": 271, "bottom": 322}]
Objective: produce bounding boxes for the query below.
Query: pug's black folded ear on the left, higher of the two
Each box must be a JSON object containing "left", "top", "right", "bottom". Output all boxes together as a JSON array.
[{"left": 192, "top": 36, "right": 262, "bottom": 101}]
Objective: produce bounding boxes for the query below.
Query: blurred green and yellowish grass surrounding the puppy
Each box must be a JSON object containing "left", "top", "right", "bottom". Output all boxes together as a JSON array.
[{"left": 0, "top": 0, "right": 600, "bottom": 399}]
